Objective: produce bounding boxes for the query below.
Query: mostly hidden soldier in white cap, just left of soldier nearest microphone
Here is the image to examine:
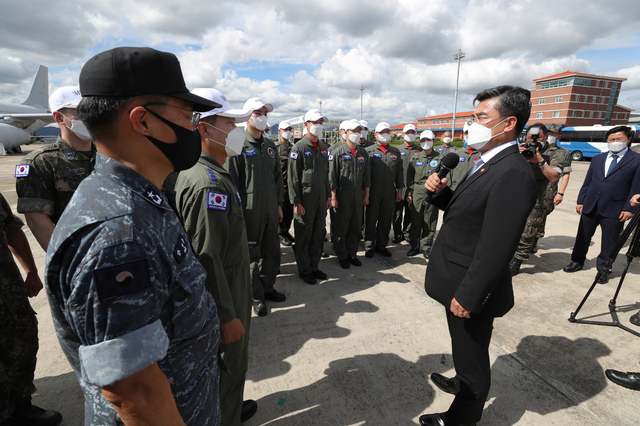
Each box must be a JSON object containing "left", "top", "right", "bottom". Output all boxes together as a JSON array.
[{"left": 391, "top": 123, "right": 422, "bottom": 244}]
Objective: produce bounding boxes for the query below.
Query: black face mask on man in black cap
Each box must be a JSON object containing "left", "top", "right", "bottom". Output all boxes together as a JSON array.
[{"left": 146, "top": 109, "right": 202, "bottom": 172}]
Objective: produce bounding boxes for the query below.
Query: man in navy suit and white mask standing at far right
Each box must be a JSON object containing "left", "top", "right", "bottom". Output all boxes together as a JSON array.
[{"left": 563, "top": 126, "right": 640, "bottom": 284}]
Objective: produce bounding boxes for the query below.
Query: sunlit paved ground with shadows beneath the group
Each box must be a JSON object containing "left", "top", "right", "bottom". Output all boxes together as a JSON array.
[{"left": 0, "top": 147, "right": 640, "bottom": 426}]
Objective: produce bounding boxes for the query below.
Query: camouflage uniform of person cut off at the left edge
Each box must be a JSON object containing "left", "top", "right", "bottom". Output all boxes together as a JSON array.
[{"left": 0, "top": 194, "right": 38, "bottom": 422}]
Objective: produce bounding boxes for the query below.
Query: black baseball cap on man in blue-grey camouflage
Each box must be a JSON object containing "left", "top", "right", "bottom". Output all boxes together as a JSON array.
[{"left": 79, "top": 47, "right": 222, "bottom": 111}]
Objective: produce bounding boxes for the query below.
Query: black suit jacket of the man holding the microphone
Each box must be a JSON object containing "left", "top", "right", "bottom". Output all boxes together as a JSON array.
[{"left": 425, "top": 146, "right": 536, "bottom": 316}]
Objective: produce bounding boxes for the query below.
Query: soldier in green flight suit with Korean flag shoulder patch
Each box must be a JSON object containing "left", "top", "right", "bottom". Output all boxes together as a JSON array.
[{"left": 175, "top": 89, "right": 257, "bottom": 426}]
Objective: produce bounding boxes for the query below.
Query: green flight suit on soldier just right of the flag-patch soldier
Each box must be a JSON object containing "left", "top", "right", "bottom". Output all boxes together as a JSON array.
[{"left": 224, "top": 130, "right": 284, "bottom": 300}]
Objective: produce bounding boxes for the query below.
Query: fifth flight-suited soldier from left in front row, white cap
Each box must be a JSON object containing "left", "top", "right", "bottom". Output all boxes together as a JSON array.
[{"left": 364, "top": 122, "right": 404, "bottom": 257}]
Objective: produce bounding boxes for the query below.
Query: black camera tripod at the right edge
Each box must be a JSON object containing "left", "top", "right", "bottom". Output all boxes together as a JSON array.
[{"left": 569, "top": 212, "right": 640, "bottom": 337}]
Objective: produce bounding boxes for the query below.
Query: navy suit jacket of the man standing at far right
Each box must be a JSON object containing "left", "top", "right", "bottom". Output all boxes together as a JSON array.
[{"left": 578, "top": 150, "right": 640, "bottom": 217}]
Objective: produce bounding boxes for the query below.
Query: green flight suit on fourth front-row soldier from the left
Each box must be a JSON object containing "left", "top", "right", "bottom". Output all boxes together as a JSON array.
[{"left": 329, "top": 143, "right": 371, "bottom": 260}]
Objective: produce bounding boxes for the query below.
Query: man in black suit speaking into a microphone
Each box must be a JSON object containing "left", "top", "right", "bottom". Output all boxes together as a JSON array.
[{"left": 420, "top": 86, "right": 536, "bottom": 426}]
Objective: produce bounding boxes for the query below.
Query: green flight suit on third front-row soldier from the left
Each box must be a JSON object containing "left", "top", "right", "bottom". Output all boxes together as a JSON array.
[{"left": 288, "top": 136, "right": 331, "bottom": 274}]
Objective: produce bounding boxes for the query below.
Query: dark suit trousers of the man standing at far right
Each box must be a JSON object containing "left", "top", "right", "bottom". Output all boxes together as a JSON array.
[{"left": 571, "top": 206, "right": 624, "bottom": 270}]
